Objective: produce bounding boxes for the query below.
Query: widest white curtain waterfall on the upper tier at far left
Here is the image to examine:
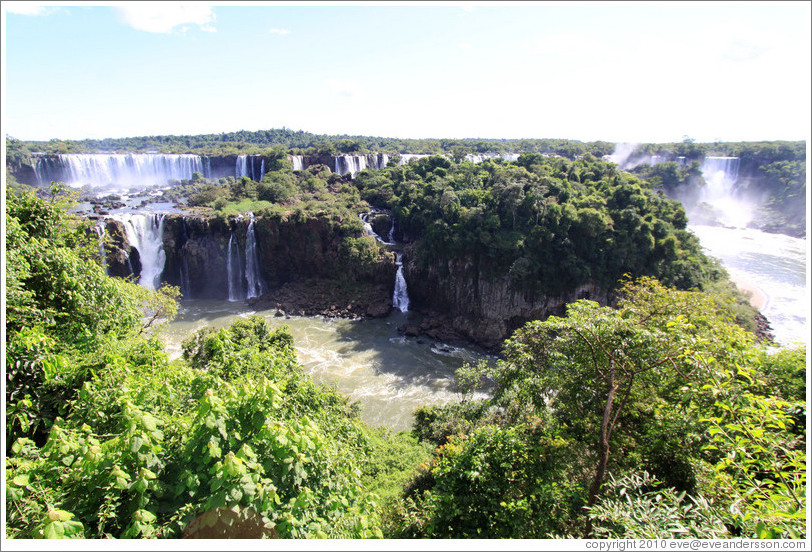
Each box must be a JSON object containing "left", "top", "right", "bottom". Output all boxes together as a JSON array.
[{"left": 32, "top": 153, "right": 209, "bottom": 189}]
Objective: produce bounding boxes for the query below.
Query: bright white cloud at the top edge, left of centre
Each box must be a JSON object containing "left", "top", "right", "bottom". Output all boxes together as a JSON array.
[{"left": 115, "top": 2, "right": 216, "bottom": 33}]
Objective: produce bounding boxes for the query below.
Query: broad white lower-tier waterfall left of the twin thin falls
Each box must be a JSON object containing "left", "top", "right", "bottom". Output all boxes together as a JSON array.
[{"left": 114, "top": 213, "right": 166, "bottom": 289}]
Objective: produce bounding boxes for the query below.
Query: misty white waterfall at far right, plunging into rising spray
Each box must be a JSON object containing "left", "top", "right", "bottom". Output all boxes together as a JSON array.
[{"left": 700, "top": 157, "right": 753, "bottom": 228}]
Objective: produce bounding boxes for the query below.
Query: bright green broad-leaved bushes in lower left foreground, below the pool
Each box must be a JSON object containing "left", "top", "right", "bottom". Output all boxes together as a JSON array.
[{"left": 7, "top": 318, "right": 382, "bottom": 538}]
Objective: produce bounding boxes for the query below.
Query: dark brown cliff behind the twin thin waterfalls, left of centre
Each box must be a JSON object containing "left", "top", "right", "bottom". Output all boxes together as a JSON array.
[{"left": 105, "top": 214, "right": 396, "bottom": 304}]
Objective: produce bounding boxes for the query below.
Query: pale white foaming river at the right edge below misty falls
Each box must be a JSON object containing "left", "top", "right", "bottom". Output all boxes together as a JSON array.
[{"left": 689, "top": 225, "right": 810, "bottom": 345}]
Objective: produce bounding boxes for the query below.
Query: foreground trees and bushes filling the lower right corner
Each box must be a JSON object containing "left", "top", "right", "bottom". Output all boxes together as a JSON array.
[{"left": 395, "top": 278, "right": 806, "bottom": 538}]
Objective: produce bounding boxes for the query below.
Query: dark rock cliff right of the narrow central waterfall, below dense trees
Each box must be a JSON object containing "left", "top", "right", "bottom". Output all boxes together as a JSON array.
[{"left": 404, "top": 248, "right": 609, "bottom": 347}]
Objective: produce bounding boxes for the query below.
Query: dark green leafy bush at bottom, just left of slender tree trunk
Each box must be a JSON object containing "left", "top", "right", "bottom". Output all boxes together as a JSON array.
[{"left": 396, "top": 423, "right": 580, "bottom": 538}]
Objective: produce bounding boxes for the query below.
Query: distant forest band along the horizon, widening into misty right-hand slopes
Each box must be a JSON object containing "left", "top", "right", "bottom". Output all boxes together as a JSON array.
[{"left": 6, "top": 132, "right": 807, "bottom": 242}]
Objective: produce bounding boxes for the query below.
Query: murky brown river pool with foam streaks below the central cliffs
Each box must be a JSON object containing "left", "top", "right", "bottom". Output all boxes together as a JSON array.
[{"left": 161, "top": 301, "right": 493, "bottom": 431}]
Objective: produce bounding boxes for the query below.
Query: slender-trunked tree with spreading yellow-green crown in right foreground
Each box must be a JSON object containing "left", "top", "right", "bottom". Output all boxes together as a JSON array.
[{"left": 482, "top": 278, "right": 751, "bottom": 535}]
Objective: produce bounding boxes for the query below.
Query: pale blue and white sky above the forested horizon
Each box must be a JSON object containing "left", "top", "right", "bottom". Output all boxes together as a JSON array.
[{"left": 1, "top": 1, "right": 812, "bottom": 143}]
